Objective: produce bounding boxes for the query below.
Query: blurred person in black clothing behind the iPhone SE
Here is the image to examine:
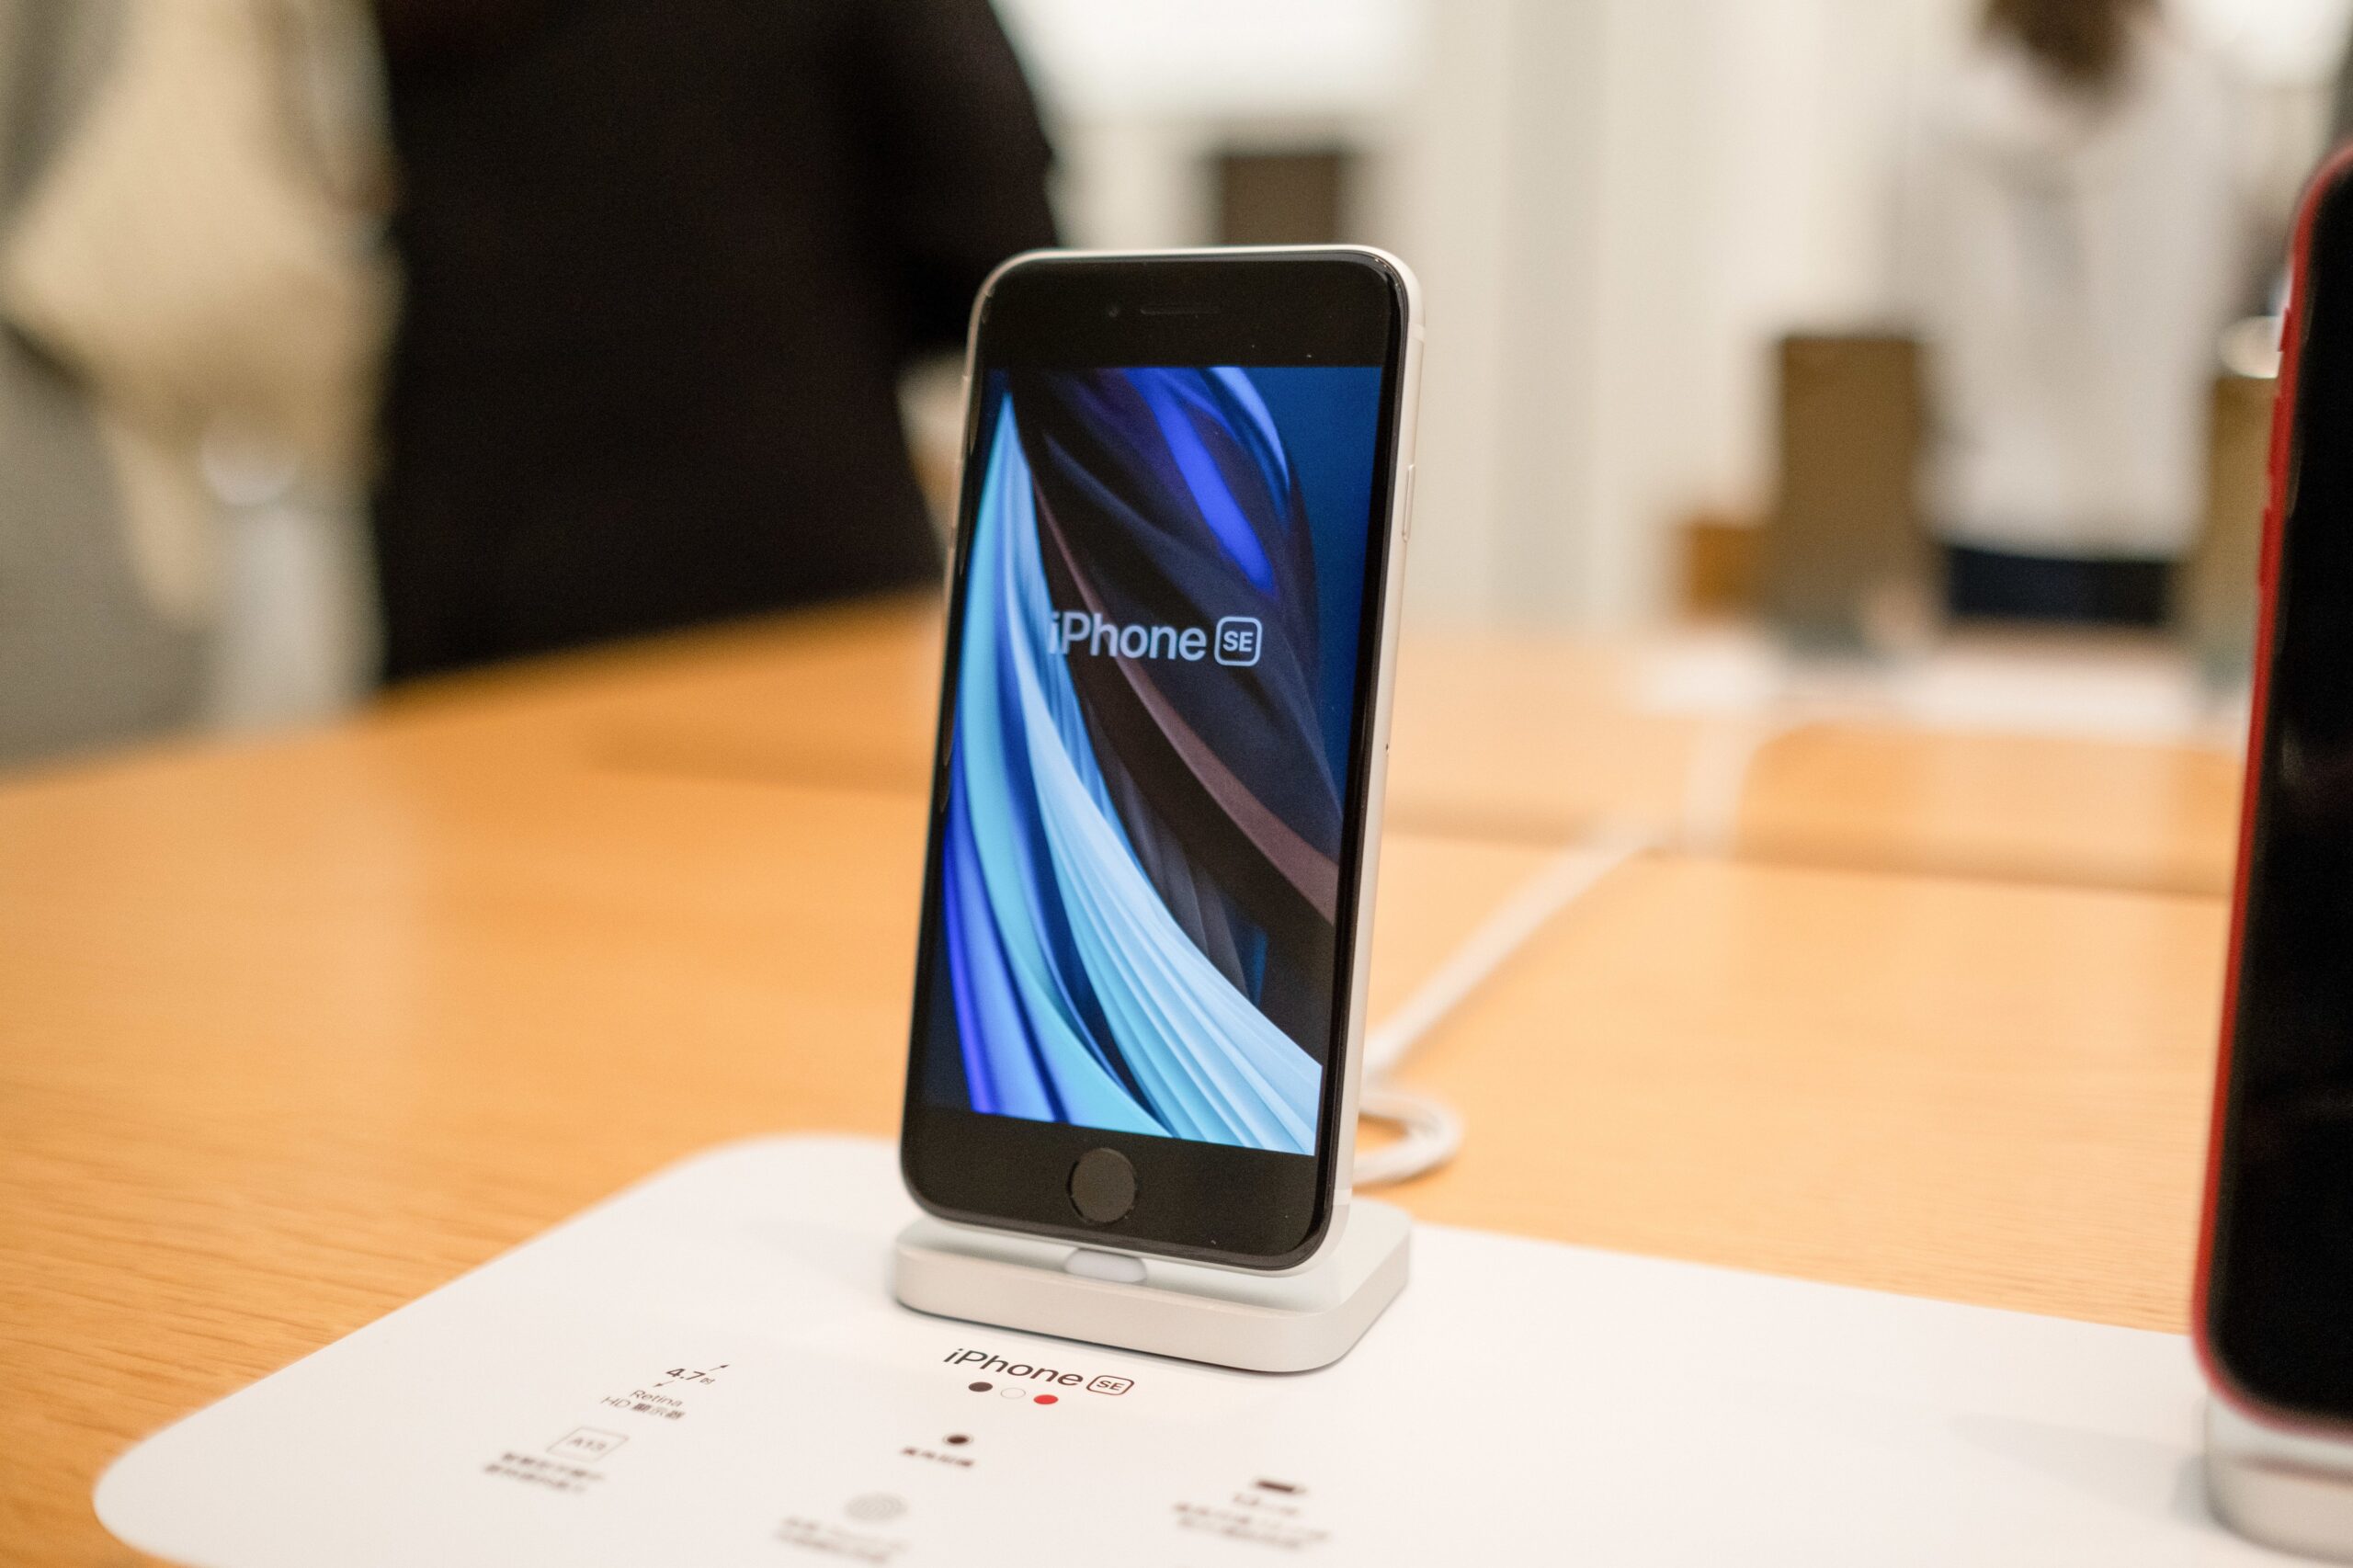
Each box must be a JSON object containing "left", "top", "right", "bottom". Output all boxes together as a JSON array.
[{"left": 374, "top": 0, "right": 1054, "bottom": 680}]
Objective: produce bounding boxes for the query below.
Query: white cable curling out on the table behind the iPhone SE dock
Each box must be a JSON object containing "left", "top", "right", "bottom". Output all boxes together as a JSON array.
[{"left": 1350, "top": 831, "right": 1652, "bottom": 1187}]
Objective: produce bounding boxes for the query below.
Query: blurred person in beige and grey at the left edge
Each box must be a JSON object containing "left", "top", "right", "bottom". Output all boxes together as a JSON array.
[{"left": 0, "top": 0, "right": 388, "bottom": 758}]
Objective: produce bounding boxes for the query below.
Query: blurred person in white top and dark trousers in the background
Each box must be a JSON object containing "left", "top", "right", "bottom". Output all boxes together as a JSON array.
[{"left": 1906, "top": 0, "right": 2252, "bottom": 624}]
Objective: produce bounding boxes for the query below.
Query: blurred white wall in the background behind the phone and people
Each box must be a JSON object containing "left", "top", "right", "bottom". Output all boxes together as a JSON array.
[{"left": 1000, "top": 0, "right": 2353, "bottom": 624}]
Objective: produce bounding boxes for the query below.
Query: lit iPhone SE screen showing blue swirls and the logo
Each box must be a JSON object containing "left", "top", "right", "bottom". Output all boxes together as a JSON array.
[{"left": 920, "top": 365, "right": 1381, "bottom": 1153}]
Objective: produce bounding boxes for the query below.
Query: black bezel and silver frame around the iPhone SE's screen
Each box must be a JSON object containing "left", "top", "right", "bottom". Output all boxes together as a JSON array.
[{"left": 899, "top": 247, "right": 1415, "bottom": 1271}]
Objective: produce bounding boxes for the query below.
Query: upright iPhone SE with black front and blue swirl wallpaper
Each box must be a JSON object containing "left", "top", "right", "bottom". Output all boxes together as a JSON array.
[{"left": 901, "top": 247, "right": 1421, "bottom": 1271}]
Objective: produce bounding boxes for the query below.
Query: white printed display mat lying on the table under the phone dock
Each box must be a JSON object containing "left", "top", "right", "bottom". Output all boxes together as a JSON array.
[{"left": 101, "top": 1140, "right": 2280, "bottom": 1568}]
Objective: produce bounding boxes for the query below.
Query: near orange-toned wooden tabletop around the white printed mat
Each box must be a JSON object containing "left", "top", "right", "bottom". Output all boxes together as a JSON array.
[{"left": 0, "top": 597, "right": 2223, "bottom": 1563}]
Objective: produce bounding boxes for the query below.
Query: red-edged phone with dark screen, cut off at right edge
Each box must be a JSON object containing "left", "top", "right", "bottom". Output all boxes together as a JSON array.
[{"left": 2195, "top": 155, "right": 2353, "bottom": 1437}]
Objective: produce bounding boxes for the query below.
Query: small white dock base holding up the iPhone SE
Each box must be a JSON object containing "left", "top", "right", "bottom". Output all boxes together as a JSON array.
[{"left": 892, "top": 1199, "right": 1412, "bottom": 1372}]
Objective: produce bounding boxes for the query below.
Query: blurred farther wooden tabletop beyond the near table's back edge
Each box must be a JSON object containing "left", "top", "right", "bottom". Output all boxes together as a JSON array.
[{"left": 427, "top": 600, "right": 2240, "bottom": 894}]
